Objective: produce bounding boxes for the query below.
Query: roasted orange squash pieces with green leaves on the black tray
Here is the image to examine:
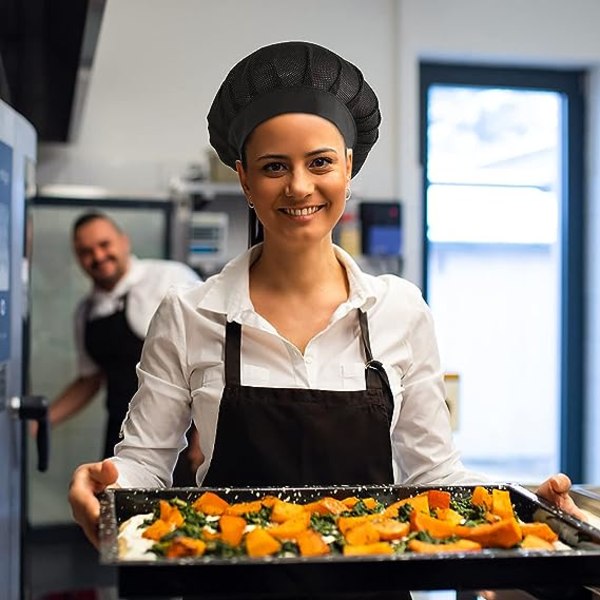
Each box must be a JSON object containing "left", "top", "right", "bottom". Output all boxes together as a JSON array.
[{"left": 118, "top": 486, "right": 558, "bottom": 560}]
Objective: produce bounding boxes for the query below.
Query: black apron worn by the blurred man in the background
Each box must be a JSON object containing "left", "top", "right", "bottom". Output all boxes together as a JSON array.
[{"left": 84, "top": 294, "right": 144, "bottom": 458}]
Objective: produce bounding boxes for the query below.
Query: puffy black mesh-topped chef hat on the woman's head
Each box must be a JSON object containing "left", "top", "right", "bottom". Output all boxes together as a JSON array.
[{"left": 208, "top": 42, "right": 381, "bottom": 177}]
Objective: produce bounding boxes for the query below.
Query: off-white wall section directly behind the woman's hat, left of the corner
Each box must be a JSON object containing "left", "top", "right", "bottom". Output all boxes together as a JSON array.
[{"left": 39, "top": 0, "right": 396, "bottom": 197}]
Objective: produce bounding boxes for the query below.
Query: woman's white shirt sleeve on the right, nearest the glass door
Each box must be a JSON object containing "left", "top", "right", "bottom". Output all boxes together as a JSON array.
[{"left": 392, "top": 300, "right": 485, "bottom": 485}]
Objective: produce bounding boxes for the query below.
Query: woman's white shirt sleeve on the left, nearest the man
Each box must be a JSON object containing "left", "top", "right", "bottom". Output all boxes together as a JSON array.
[{"left": 113, "top": 291, "right": 192, "bottom": 487}]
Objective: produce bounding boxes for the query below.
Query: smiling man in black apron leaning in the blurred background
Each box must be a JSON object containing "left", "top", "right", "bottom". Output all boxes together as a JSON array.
[{"left": 44, "top": 212, "right": 202, "bottom": 485}]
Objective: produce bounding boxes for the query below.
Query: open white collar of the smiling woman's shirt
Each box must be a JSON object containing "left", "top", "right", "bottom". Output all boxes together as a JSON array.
[{"left": 197, "top": 244, "right": 377, "bottom": 323}]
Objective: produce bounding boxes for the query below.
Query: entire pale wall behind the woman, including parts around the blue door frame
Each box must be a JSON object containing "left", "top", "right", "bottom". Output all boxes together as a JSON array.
[{"left": 39, "top": 0, "right": 600, "bottom": 482}]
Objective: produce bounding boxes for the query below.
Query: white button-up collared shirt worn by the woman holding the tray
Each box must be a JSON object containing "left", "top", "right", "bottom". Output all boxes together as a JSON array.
[{"left": 113, "top": 247, "right": 481, "bottom": 487}]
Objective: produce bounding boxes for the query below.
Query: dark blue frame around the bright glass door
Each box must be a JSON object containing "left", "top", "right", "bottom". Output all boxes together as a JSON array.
[{"left": 419, "top": 62, "right": 587, "bottom": 482}]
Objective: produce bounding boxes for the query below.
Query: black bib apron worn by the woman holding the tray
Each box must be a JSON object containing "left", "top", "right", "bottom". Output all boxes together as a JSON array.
[{"left": 203, "top": 311, "right": 393, "bottom": 487}]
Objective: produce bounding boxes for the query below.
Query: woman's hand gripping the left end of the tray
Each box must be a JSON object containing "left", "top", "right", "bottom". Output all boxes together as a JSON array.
[{"left": 69, "top": 459, "right": 119, "bottom": 548}]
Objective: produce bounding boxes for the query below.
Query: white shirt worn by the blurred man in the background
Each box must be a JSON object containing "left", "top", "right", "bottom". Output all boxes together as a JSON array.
[{"left": 75, "top": 256, "right": 200, "bottom": 377}]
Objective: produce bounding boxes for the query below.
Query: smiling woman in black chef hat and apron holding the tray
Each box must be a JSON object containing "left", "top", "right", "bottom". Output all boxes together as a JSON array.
[{"left": 70, "top": 42, "right": 577, "bottom": 542}]
